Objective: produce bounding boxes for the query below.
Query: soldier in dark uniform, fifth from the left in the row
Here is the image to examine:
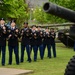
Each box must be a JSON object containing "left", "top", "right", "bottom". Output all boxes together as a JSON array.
[{"left": 37, "top": 26, "right": 43, "bottom": 59}]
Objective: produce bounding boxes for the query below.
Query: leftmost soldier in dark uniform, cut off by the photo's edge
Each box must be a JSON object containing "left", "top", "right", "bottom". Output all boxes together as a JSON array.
[{"left": 0, "top": 18, "right": 7, "bottom": 66}]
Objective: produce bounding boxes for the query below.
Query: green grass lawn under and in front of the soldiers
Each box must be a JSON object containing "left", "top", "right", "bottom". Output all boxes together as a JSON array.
[{"left": 0, "top": 43, "right": 75, "bottom": 75}]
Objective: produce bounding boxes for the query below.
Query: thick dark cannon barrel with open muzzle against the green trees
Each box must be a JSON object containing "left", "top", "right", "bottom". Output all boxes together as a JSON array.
[{"left": 43, "top": 2, "right": 75, "bottom": 22}]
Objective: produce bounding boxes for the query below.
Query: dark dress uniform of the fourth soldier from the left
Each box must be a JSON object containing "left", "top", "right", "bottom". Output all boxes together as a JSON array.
[{"left": 31, "top": 30, "right": 38, "bottom": 61}]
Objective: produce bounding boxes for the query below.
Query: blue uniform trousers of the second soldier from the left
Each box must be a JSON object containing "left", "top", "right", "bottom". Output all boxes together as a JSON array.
[{"left": 8, "top": 46, "right": 19, "bottom": 64}]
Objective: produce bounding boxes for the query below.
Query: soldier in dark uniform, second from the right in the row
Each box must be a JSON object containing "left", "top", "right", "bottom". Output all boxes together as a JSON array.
[{"left": 43, "top": 27, "right": 51, "bottom": 58}]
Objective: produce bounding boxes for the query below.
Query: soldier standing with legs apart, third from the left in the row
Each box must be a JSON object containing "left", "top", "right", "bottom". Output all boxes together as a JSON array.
[{"left": 21, "top": 22, "right": 31, "bottom": 62}]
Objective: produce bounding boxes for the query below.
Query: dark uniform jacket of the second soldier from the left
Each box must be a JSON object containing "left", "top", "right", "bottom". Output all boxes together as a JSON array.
[{"left": 8, "top": 27, "right": 20, "bottom": 46}]
